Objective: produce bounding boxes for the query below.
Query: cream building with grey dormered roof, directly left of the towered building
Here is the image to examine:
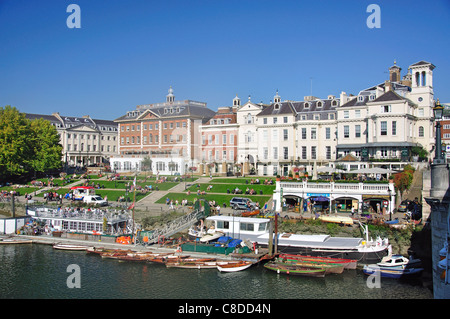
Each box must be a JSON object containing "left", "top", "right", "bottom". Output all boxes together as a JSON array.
[{"left": 257, "top": 92, "right": 339, "bottom": 175}]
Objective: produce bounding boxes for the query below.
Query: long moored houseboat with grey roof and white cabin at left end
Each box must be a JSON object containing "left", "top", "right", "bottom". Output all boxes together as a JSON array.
[{"left": 206, "top": 215, "right": 389, "bottom": 264}]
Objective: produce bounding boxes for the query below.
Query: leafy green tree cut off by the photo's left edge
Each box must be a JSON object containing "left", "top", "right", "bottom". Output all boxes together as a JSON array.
[{"left": 0, "top": 105, "right": 34, "bottom": 179}]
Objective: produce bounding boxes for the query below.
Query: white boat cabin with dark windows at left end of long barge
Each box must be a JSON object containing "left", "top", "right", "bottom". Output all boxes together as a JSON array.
[{"left": 206, "top": 215, "right": 270, "bottom": 239}]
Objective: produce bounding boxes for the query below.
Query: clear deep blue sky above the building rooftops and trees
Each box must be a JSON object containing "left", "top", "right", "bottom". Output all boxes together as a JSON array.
[{"left": 0, "top": 0, "right": 450, "bottom": 119}]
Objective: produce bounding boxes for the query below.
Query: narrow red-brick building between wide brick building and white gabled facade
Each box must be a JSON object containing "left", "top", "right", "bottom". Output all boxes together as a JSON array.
[{"left": 199, "top": 96, "right": 240, "bottom": 175}]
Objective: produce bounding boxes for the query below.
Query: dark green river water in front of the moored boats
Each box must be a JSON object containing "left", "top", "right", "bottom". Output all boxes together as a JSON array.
[{"left": 0, "top": 244, "right": 433, "bottom": 300}]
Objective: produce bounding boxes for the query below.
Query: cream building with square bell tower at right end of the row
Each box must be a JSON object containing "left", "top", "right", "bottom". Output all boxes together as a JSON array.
[{"left": 336, "top": 61, "right": 434, "bottom": 160}]
